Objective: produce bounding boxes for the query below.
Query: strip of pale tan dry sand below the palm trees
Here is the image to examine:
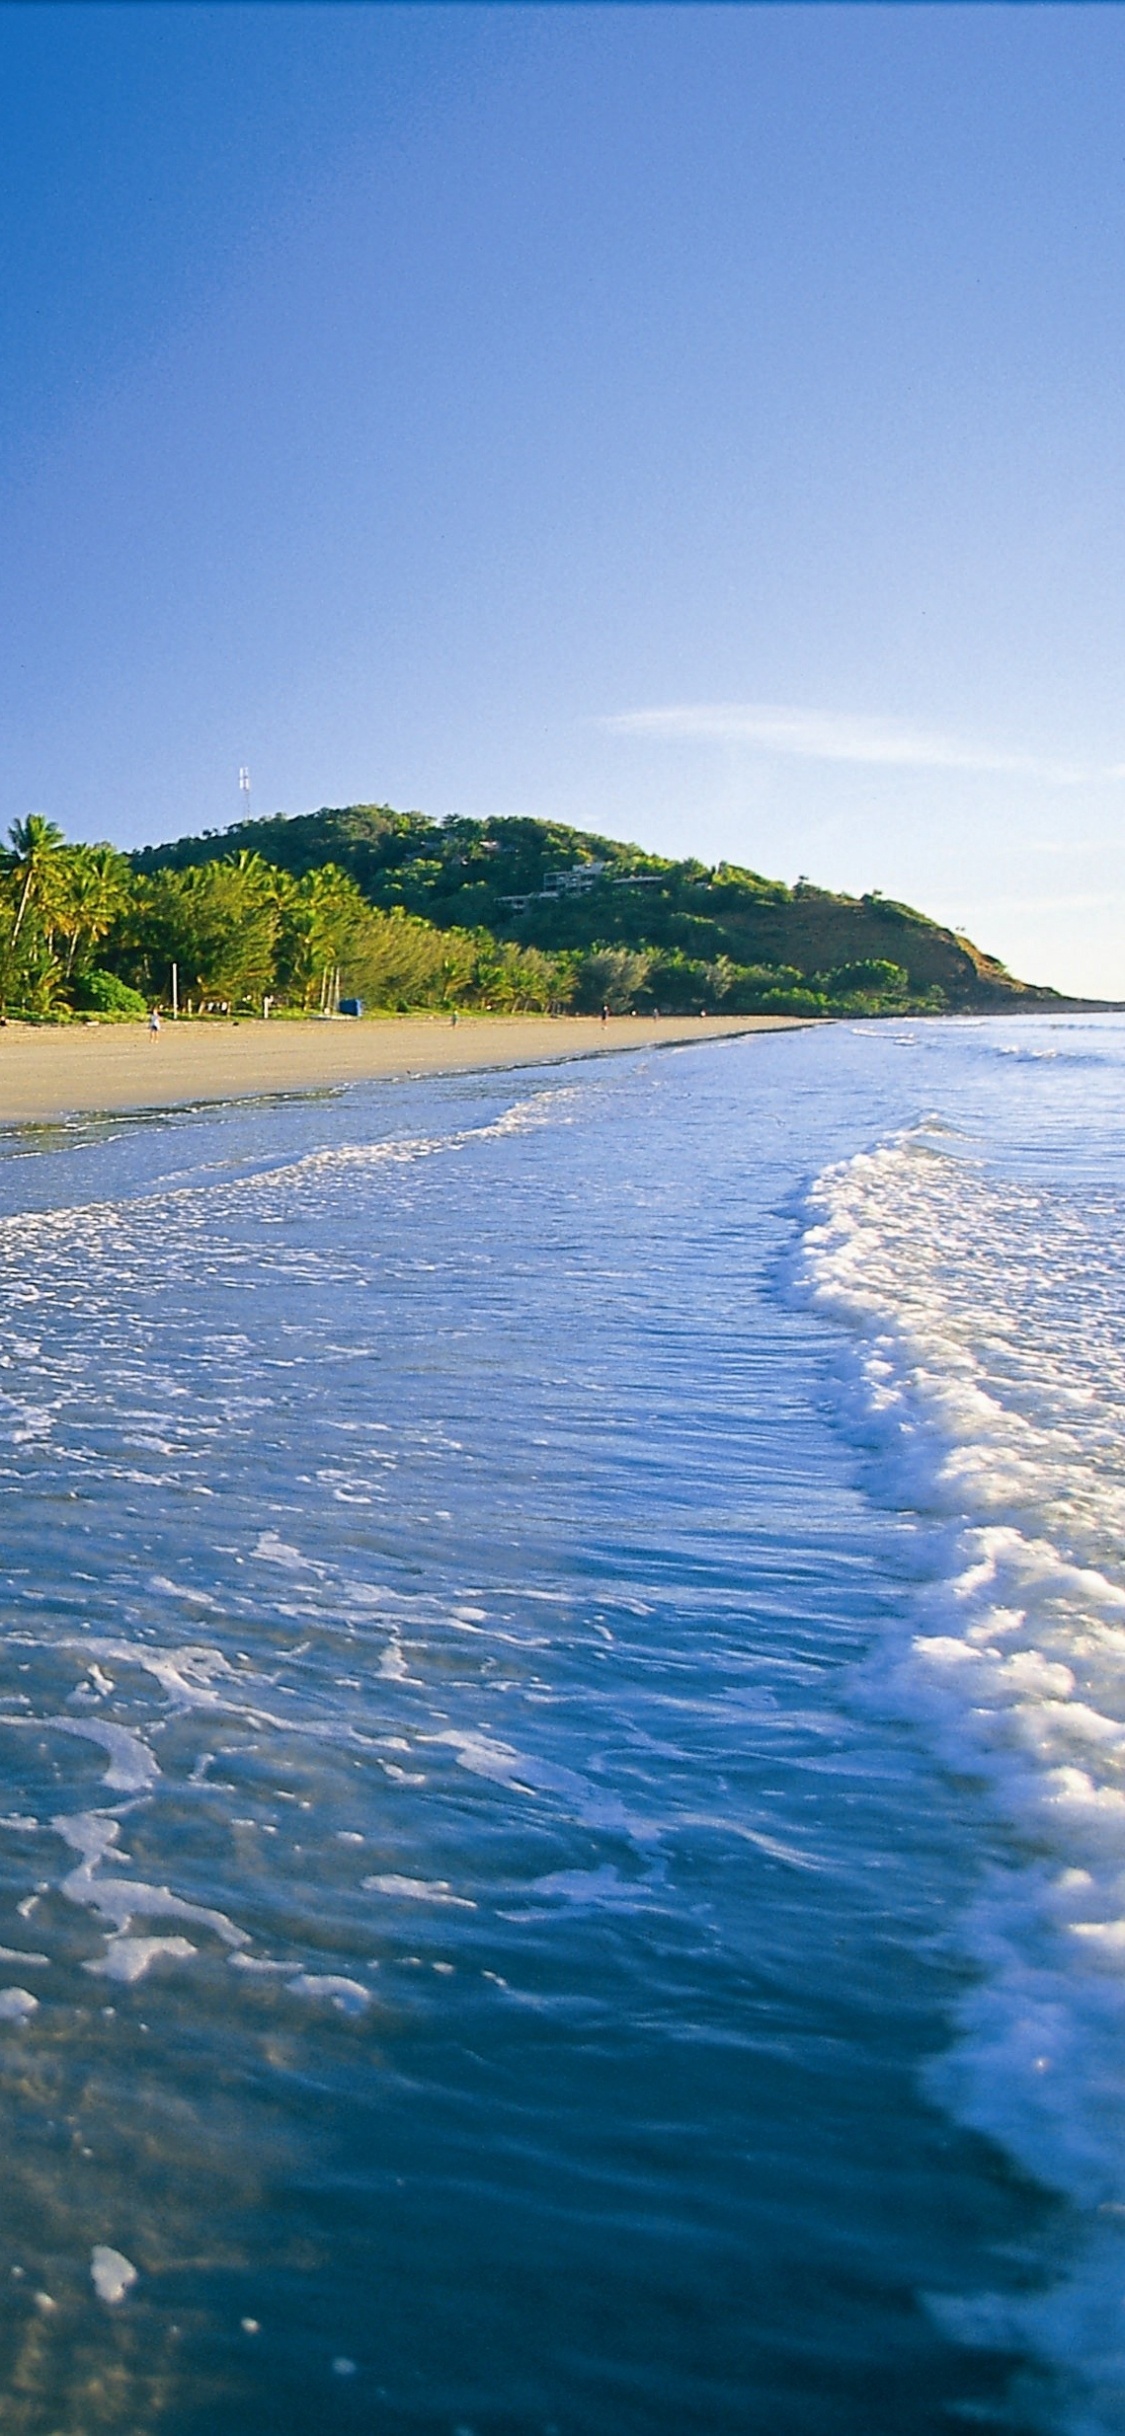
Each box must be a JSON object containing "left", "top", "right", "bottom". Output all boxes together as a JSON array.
[{"left": 0, "top": 1016, "right": 801, "bottom": 1123}]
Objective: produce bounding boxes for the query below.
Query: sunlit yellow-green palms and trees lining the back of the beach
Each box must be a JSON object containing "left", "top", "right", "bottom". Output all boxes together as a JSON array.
[{"left": 0, "top": 814, "right": 913, "bottom": 1021}]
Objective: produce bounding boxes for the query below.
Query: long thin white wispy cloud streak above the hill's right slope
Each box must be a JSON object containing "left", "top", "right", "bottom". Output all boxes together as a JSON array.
[{"left": 601, "top": 702, "right": 1100, "bottom": 787}]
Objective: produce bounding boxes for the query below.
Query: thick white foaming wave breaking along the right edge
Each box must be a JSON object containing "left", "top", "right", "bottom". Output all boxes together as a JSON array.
[{"left": 801, "top": 1123, "right": 1125, "bottom": 2436}]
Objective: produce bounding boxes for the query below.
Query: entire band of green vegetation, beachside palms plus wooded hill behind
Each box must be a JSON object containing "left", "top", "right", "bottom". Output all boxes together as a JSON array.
[{"left": 0, "top": 806, "right": 1059, "bottom": 1021}]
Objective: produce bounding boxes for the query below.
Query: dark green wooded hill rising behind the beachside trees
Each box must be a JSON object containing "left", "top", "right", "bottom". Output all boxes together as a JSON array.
[{"left": 131, "top": 804, "right": 1074, "bottom": 1013}]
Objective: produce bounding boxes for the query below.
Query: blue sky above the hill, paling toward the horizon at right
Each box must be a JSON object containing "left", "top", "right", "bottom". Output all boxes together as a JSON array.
[{"left": 0, "top": 0, "right": 1125, "bottom": 996}]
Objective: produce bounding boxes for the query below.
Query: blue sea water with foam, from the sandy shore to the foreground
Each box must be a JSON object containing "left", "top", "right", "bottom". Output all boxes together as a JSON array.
[{"left": 0, "top": 1018, "right": 1125, "bottom": 2436}]
